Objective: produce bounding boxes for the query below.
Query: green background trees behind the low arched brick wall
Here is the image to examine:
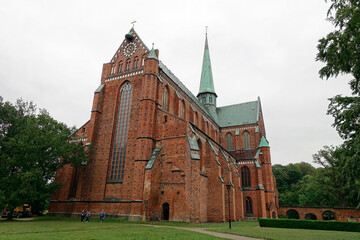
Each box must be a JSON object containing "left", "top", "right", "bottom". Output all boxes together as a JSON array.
[{"left": 273, "top": 154, "right": 360, "bottom": 207}]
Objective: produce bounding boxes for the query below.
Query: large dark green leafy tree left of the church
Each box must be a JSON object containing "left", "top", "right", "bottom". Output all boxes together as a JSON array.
[{"left": 0, "top": 97, "right": 91, "bottom": 217}]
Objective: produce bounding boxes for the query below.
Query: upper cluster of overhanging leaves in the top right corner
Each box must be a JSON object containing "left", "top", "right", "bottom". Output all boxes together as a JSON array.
[{"left": 316, "top": 0, "right": 360, "bottom": 90}]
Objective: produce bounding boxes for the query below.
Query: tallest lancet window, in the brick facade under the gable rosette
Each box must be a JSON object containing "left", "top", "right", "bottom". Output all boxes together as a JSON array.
[{"left": 109, "top": 82, "right": 132, "bottom": 182}]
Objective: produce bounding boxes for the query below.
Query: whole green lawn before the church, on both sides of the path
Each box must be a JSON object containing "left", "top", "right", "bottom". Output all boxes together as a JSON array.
[{"left": 0, "top": 217, "right": 360, "bottom": 240}]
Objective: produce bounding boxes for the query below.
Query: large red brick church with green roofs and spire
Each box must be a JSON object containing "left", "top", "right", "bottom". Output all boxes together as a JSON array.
[{"left": 49, "top": 28, "right": 278, "bottom": 222}]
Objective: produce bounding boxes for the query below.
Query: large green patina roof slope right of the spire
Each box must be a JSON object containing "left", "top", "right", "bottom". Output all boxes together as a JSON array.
[{"left": 217, "top": 99, "right": 260, "bottom": 127}]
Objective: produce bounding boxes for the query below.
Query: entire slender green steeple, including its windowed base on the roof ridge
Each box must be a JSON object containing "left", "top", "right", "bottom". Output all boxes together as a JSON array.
[{"left": 197, "top": 32, "right": 218, "bottom": 121}]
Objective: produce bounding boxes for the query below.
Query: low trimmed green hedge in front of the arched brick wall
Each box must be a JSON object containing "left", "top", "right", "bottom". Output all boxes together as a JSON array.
[{"left": 259, "top": 218, "right": 360, "bottom": 232}]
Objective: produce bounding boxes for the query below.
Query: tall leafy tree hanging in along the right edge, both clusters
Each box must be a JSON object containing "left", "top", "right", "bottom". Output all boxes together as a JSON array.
[{"left": 316, "top": 0, "right": 360, "bottom": 199}]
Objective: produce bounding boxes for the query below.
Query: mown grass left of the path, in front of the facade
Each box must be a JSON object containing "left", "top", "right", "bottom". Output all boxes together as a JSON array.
[{"left": 0, "top": 217, "right": 222, "bottom": 240}]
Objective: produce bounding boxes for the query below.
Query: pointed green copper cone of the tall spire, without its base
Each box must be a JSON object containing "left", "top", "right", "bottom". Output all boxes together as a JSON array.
[{"left": 199, "top": 35, "right": 215, "bottom": 94}]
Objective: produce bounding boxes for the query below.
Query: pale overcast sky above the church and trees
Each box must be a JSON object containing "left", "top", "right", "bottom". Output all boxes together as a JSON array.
[{"left": 0, "top": 0, "right": 350, "bottom": 165}]
